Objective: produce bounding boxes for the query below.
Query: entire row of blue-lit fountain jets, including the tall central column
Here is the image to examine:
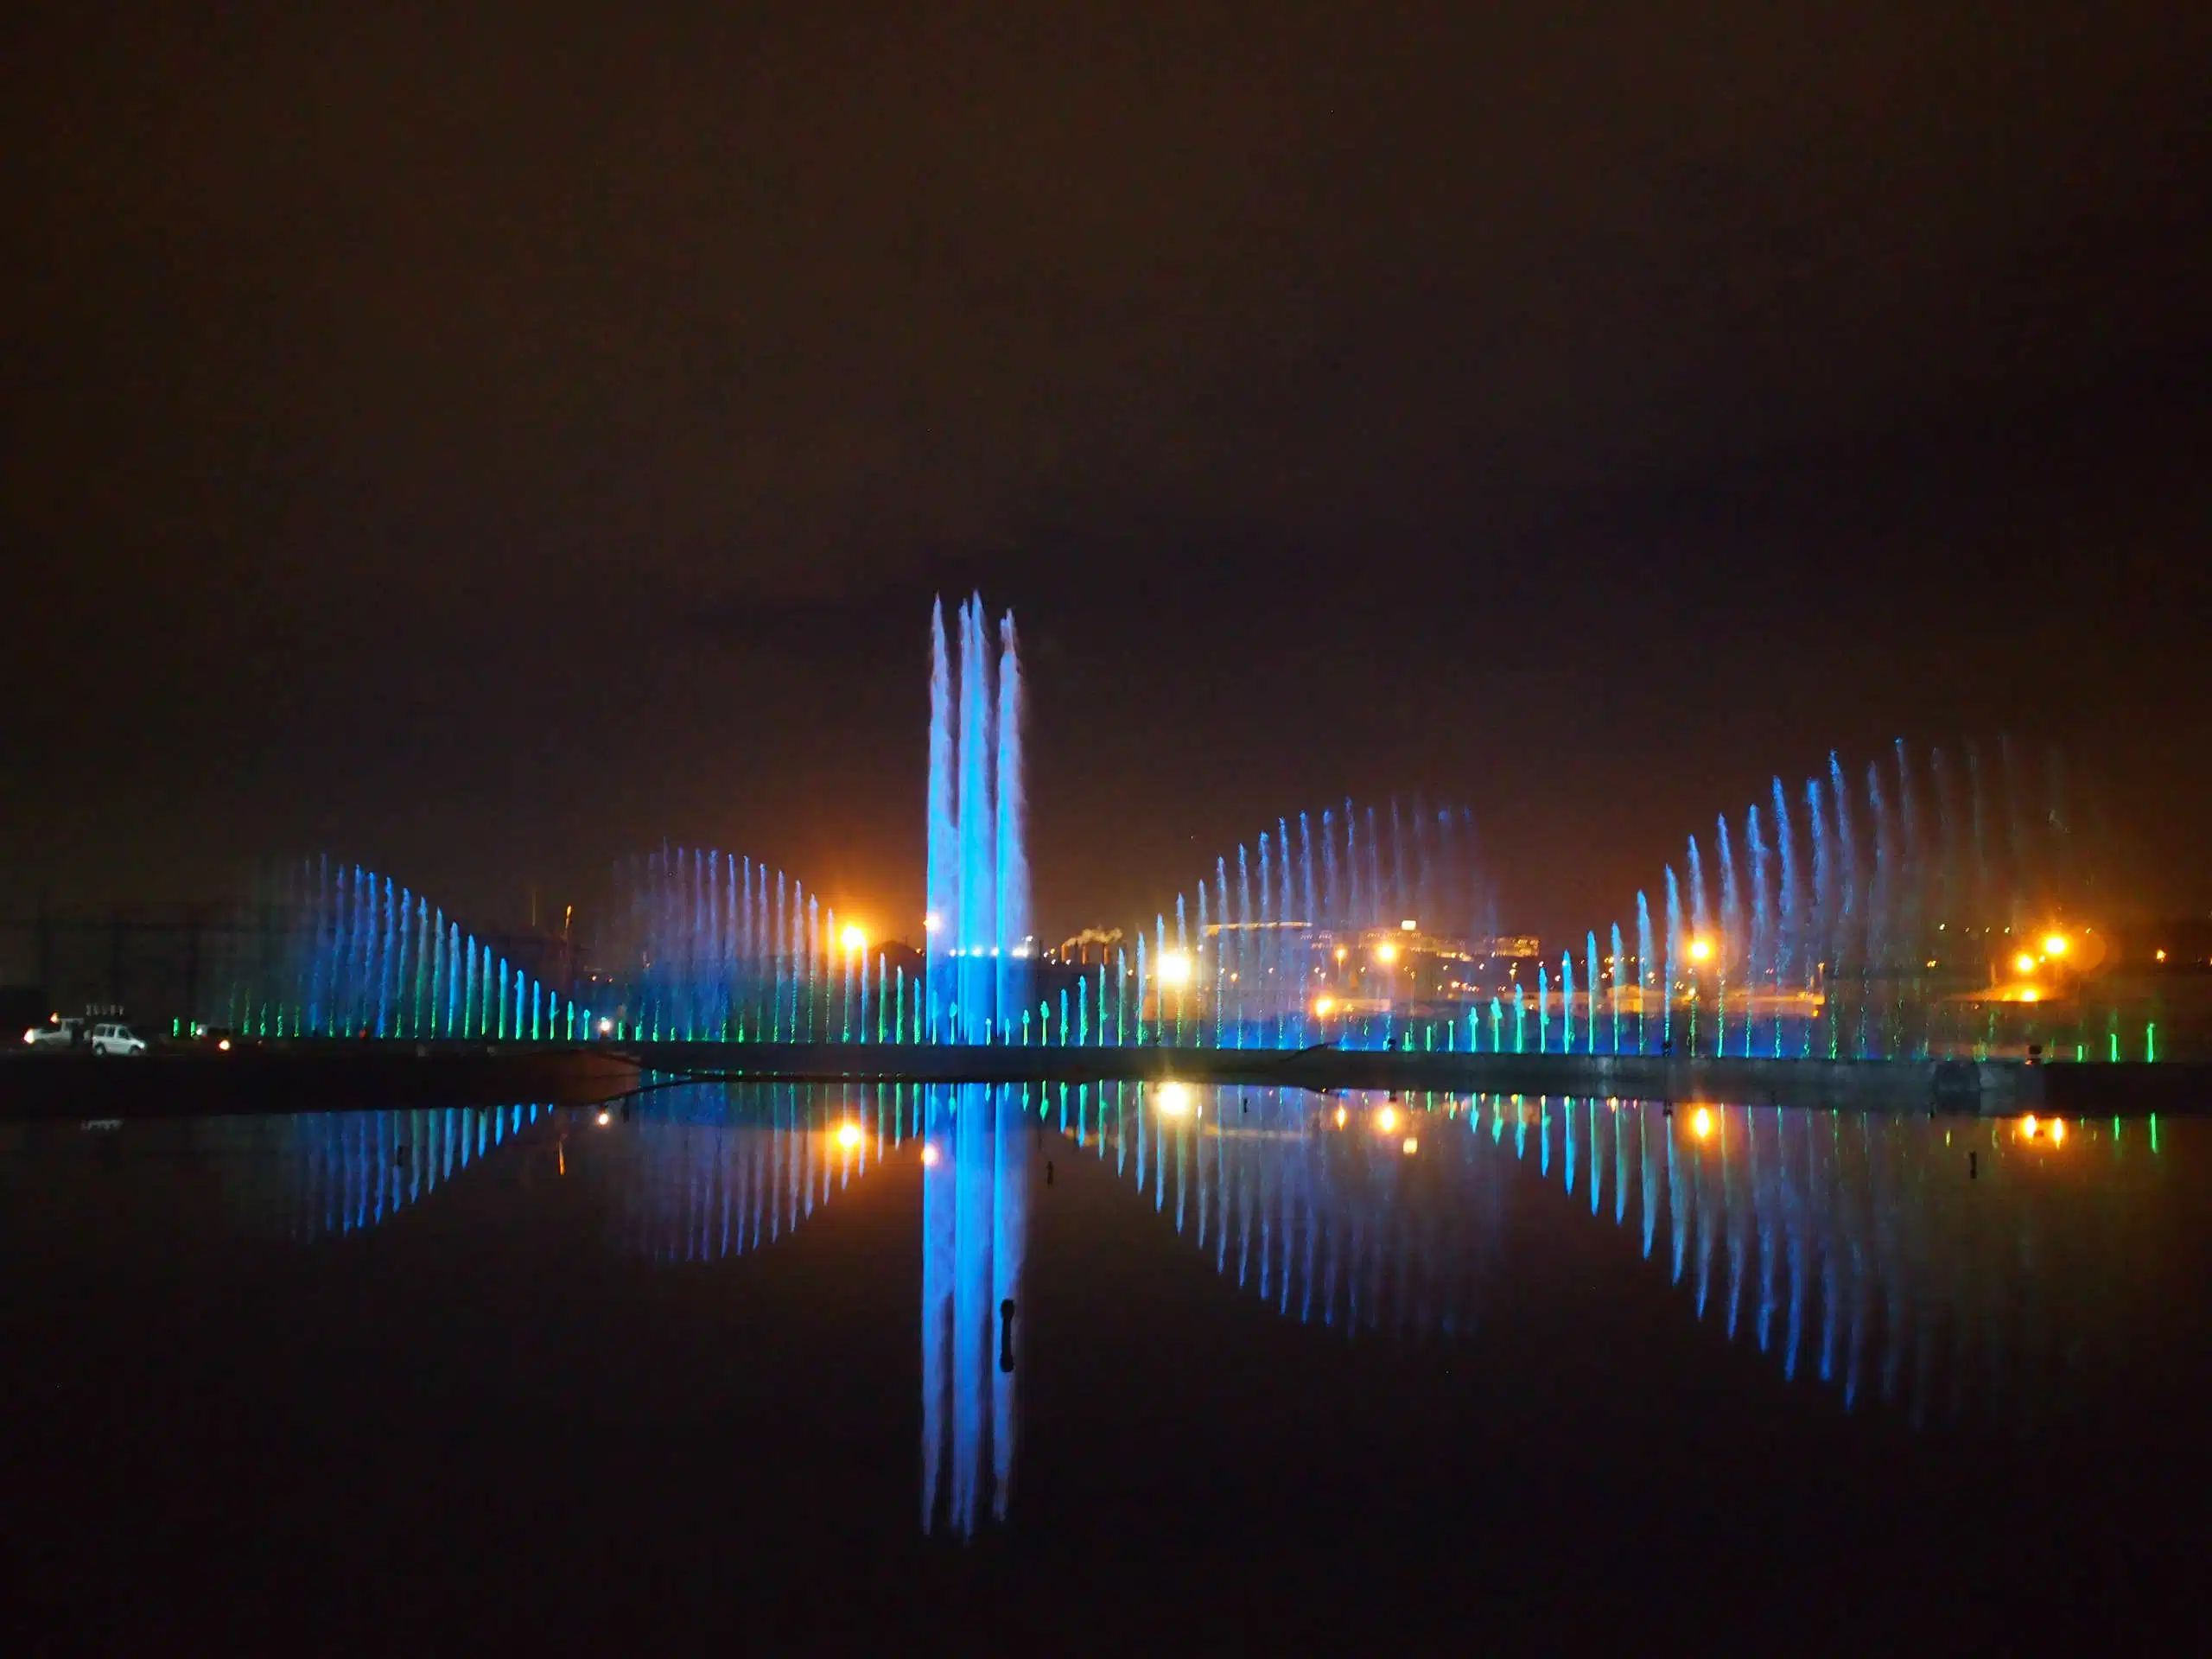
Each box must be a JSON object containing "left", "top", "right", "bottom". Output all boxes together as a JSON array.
[{"left": 224, "top": 597, "right": 2093, "bottom": 1055}]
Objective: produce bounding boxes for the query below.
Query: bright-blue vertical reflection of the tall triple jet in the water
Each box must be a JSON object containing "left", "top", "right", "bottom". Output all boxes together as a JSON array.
[{"left": 923, "top": 1084, "right": 1035, "bottom": 1537}]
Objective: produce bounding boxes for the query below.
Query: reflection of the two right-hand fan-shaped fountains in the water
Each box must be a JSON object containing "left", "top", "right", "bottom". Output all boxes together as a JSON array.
[{"left": 1059, "top": 1084, "right": 2165, "bottom": 1427}]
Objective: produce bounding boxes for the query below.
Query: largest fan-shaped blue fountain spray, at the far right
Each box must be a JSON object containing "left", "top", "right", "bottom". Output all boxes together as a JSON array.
[{"left": 1645, "top": 741, "right": 2123, "bottom": 1059}]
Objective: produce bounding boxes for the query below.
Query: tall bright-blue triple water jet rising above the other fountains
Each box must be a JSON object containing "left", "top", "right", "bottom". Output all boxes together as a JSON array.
[{"left": 925, "top": 595, "right": 1028, "bottom": 1042}]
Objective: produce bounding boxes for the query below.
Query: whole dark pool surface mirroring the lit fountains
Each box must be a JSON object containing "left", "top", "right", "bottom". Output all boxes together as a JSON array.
[{"left": 0, "top": 1086, "right": 2212, "bottom": 1650}]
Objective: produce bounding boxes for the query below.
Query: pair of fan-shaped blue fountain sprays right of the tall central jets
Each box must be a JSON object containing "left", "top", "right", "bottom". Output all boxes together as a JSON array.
[{"left": 1101, "top": 743, "right": 2123, "bottom": 1059}]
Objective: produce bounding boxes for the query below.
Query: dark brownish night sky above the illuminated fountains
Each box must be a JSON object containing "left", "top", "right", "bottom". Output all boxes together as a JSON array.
[{"left": 0, "top": 0, "right": 2212, "bottom": 955}]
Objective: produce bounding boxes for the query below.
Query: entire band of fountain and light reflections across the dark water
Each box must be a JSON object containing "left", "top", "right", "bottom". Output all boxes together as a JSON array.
[{"left": 0, "top": 1084, "right": 2196, "bottom": 1537}]
